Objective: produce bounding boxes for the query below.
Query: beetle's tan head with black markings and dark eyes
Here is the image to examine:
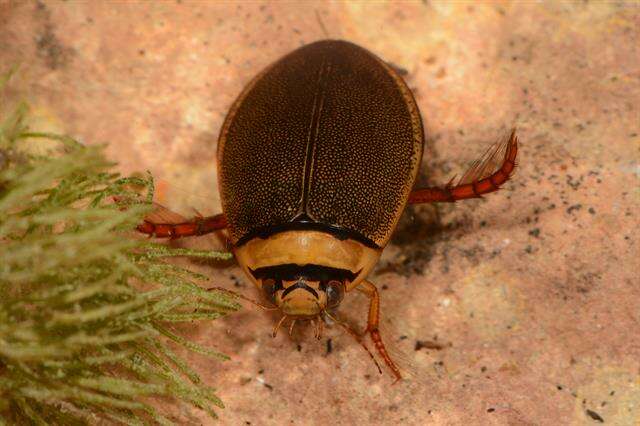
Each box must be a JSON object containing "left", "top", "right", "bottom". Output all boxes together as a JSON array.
[{"left": 251, "top": 264, "right": 358, "bottom": 318}]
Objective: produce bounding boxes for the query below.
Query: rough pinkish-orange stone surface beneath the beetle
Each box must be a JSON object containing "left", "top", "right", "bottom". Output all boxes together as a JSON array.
[{"left": 0, "top": 0, "right": 640, "bottom": 425}]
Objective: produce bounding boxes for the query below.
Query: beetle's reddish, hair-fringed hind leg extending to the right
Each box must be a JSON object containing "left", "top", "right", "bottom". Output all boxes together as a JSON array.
[{"left": 409, "top": 129, "right": 518, "bottom": 204}]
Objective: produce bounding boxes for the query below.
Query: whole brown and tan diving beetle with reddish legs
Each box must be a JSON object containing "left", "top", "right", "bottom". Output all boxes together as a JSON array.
[{"left": 138, "top": 40, "right": 518, "bottom": 379}]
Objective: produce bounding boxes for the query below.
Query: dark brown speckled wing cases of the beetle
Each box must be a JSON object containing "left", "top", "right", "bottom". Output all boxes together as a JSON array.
[{"left": 218, "top": 41, "right": 423, "bottom": 246}]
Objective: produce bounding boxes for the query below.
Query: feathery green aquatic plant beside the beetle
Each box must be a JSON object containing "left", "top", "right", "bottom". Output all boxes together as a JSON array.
[{"left": 0, "top": 71, "right": 239, "bottom": 425}]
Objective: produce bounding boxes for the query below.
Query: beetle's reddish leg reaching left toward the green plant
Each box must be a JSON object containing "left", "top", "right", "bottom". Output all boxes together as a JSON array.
[{"left": 136, "top": 213, "right": 227, "bottom": 238}]
